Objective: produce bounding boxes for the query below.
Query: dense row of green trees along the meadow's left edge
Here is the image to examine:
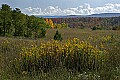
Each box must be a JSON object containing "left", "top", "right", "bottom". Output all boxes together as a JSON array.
[{"left": 0, "top": 4, "right": 50, "bottom": 38}]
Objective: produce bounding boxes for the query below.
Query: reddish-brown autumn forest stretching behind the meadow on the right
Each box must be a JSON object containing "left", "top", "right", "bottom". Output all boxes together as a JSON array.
[{"left": 51, "top": 17, "right": 120, "bottom": 30}]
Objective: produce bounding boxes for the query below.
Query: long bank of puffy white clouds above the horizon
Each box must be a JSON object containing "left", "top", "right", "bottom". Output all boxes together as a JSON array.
[{"left": 22, "top": 3, "right": 120, "bottom": 15}]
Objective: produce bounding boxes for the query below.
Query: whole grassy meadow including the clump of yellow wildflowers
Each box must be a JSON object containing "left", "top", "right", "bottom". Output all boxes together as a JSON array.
[{"left": 0, "top": 28, "right": 120, "bottom": 80}]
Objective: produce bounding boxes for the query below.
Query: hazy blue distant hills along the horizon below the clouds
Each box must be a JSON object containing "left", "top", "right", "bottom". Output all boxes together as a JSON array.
[{"left": 35, "top": 13, "right": 120, "bottom": 18}]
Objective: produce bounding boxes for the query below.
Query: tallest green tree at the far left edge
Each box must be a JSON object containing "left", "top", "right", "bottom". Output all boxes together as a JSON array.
[{"left": 0, "top": 4, "right": 12, "bottom": 36}]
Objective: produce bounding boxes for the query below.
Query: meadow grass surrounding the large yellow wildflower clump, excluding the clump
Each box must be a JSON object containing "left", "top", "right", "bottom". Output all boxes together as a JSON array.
[{"left": 0, "top": 28, "right": 120, "bottom": 80}]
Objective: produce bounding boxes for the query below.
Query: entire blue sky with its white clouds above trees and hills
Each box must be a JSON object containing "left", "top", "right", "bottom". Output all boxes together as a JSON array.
[{"left": 0, "top": 0, "right": 120, "bottom": 15}]
